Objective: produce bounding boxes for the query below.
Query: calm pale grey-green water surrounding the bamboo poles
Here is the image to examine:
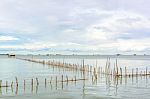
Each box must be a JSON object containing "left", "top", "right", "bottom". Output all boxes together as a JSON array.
[{"left": 0, "top": 55, "right": 150, "bottom": 99}]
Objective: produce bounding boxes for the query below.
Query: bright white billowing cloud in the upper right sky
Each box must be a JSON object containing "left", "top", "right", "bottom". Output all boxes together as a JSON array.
[{"left": 84, "top": 11, "right": 150, "bottom": 40}]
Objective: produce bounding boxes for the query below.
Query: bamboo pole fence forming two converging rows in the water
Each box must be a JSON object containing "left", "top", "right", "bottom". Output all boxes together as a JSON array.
[{"left": 0, "top": 57, "right": 150, "bottom": 94}]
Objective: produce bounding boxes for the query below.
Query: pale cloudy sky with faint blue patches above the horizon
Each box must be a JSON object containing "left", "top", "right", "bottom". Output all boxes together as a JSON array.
[{"left": 0, "top": 0, "right": 150, "bottom": 54}]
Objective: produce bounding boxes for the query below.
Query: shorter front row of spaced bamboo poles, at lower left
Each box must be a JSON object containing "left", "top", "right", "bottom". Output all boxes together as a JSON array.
[{"left": 0, "top": 75, "right": 87, "bottom": 94}]
